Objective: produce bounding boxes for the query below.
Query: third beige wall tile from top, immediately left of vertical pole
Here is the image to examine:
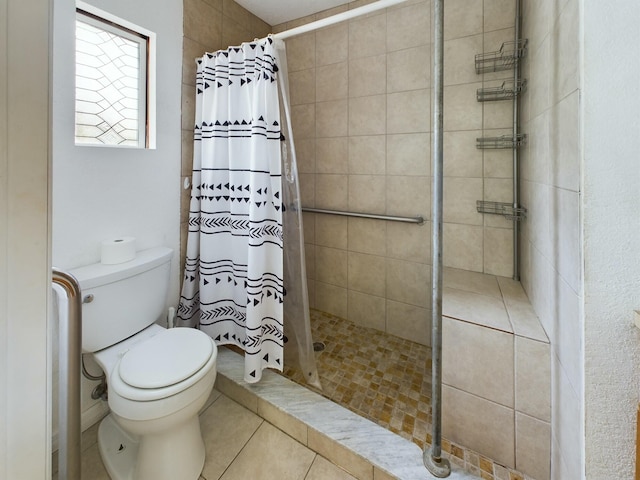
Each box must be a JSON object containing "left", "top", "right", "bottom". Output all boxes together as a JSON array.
[{"left": 387, "top": 90, "right": 431, "bottom": 133}]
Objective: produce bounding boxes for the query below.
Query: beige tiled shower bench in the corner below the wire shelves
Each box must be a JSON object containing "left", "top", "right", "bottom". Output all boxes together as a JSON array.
[{"left": 442, "top": 268, "right": 551, "bottom": 480}]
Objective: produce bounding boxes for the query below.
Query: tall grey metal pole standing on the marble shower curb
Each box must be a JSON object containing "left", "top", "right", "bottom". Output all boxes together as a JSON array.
[{"left": 423, "top": 0, "right": 451, "bottom": 478}]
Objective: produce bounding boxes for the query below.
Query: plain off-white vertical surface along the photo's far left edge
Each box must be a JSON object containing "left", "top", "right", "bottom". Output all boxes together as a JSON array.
[{"left": 0, "top": 0, "right": 51, "bottom": 479}]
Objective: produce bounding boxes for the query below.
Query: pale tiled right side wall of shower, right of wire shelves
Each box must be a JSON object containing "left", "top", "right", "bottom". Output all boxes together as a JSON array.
[{"left": 521, "top": 0, "right": 584, "bottom": 480}]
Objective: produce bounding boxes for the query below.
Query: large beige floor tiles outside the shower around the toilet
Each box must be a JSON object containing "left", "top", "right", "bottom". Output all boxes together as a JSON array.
[{"left": 53, "top": 390, "right": 356, "bottom": 480}]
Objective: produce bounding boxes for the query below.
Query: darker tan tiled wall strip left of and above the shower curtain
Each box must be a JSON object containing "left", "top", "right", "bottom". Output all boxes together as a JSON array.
[{"left": 180, "top": 0, "right": 271, "bottom": 271}]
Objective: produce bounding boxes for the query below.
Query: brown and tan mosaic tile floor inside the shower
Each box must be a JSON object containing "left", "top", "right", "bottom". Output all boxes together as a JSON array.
[{"left": 284, "top": 310, "right": 531, "bottom": 480}]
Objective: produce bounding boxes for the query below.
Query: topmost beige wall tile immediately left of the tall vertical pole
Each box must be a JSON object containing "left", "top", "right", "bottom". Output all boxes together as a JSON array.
[{"left": 387, "top": 2, "right": 431, "bottom": 52}]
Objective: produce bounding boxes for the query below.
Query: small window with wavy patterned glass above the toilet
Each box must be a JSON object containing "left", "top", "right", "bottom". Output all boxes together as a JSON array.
[{"left": 75, "top": 10, "right": 149, "bottom": 148}]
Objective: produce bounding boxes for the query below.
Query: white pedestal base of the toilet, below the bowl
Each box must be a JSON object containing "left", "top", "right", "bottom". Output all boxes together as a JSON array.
[{"left": 98, "top": 414, "right": 205, "bottom": 480}]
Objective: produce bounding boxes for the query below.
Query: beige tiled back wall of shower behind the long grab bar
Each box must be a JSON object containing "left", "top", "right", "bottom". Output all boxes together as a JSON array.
[{"left": 274, "top": 0, "right": 514, "bottom": 344}]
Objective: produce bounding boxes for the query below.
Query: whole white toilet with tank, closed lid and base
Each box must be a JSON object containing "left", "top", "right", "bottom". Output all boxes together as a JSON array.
[{"left": 71, "top": 247, "right": 217, "bottom": 480}]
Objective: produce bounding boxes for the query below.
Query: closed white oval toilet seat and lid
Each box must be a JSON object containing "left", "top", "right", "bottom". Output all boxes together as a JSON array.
[{"left": 109, "top": 328, "right": 217, "bottom": 402}]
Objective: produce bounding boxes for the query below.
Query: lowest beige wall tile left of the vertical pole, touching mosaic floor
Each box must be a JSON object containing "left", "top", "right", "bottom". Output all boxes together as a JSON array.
[{"left": 387, "top": 300, "right": 431, "bottom": 346}]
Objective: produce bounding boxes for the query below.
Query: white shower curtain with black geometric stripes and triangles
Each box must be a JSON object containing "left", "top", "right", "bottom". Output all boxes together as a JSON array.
[{"left": 177, "top": 38, "right": 317, "bottom": 390}]
